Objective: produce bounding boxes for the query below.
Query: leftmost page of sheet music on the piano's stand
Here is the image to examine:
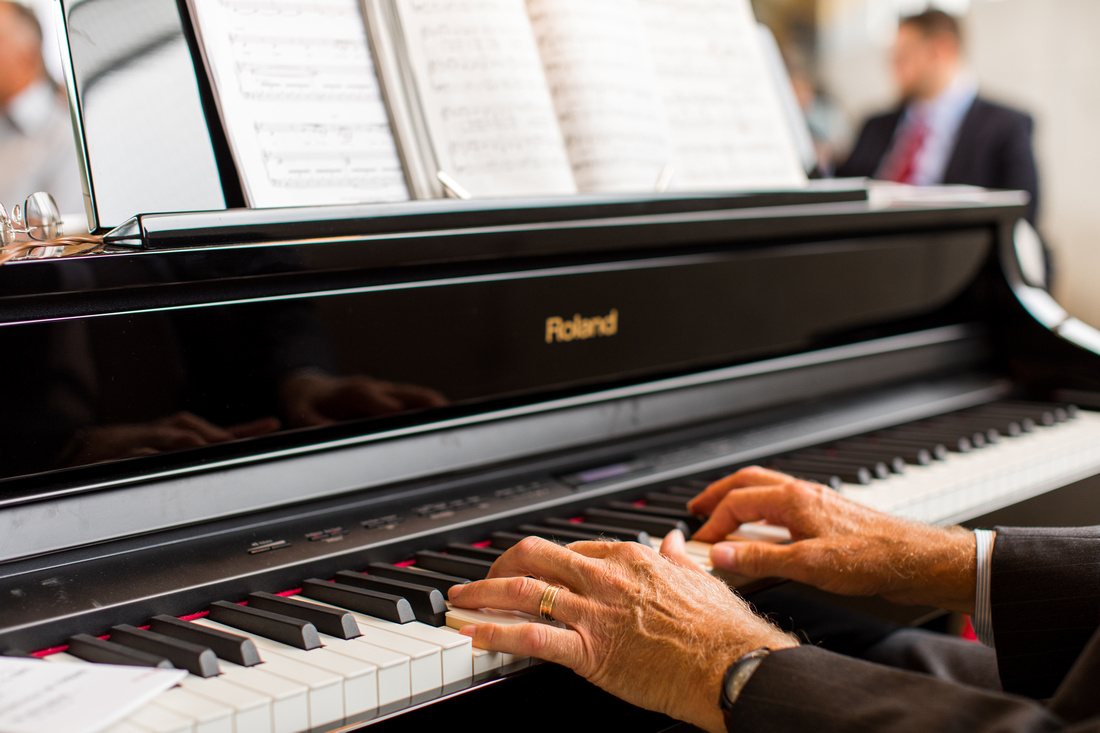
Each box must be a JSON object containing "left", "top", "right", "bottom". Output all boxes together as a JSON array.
[{"left": 188, "top": 0, "right": 409, "bottom": 207}]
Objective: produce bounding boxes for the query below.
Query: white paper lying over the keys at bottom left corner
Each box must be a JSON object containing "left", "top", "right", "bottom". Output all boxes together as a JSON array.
[{"left": 0, "top": 657, "right": 187, "bottom": 733}]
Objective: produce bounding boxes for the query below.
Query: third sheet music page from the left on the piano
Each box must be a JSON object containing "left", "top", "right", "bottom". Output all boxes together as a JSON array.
[{"left": 527, "top": 0, "right": 673, "bottom": 192}]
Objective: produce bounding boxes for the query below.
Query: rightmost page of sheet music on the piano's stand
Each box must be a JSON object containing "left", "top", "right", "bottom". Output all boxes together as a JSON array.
[{"left": 638, "top": 0, "right": 805, "bottom": 189}]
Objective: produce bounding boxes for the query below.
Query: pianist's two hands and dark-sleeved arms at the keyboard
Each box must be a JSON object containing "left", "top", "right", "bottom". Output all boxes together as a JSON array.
[{"left": 451, "top": 468, "right": 1100, "bottom": 731}]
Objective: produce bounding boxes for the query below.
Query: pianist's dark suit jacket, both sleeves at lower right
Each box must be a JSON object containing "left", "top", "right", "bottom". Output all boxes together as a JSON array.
[{"left": 729, "top": 527, "right": 1100, "bottom": 731}]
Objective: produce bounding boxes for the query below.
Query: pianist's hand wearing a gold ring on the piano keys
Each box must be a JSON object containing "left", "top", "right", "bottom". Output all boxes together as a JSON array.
[{"left": 450, "top": 532, "right": 798, "bottom": 731}]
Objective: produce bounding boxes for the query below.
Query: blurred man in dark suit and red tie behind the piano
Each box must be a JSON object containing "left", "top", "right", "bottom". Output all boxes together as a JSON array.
[{"left": 837, "top": 10, "right": 1038, "bottom": 222}]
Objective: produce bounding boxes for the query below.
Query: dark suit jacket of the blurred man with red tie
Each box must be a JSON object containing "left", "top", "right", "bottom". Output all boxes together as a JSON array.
[{"left": 836, "top": 97, "right": 1038, "bottom": 222}]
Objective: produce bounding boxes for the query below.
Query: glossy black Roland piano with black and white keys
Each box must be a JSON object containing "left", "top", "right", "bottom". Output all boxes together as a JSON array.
[{"left": 0, "top": 2, "right": 1100, "bottom": 733}]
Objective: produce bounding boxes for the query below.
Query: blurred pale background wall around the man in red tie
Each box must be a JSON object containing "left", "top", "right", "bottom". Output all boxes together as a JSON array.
[{"left": 754, "top": 0, "right": 1100, "bottom": 326}]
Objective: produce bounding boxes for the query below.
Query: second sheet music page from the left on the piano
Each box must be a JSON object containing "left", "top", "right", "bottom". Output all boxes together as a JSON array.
[{"left": 396, "top": 0, "right": 576, "bottom": 196}]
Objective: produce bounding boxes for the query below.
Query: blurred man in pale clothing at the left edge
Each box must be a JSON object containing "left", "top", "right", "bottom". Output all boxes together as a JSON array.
[{"left": 0, "top": 0, "right": 84, "bottom": 214}]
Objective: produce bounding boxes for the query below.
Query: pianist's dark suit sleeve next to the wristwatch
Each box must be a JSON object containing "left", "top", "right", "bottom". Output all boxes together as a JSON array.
[{"left": 727, "top": 646, "right": 1066, "bottom": 733}]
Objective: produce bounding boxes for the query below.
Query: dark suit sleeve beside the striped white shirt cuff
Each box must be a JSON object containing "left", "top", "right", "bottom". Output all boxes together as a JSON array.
[{"left": 990, "top": 527, "right": 1100, "bottom": 698}]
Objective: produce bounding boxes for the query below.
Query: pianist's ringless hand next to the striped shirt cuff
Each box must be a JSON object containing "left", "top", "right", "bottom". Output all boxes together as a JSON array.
[{"left": 688, "top": 467, "right": 977, "bottom": 613}]
